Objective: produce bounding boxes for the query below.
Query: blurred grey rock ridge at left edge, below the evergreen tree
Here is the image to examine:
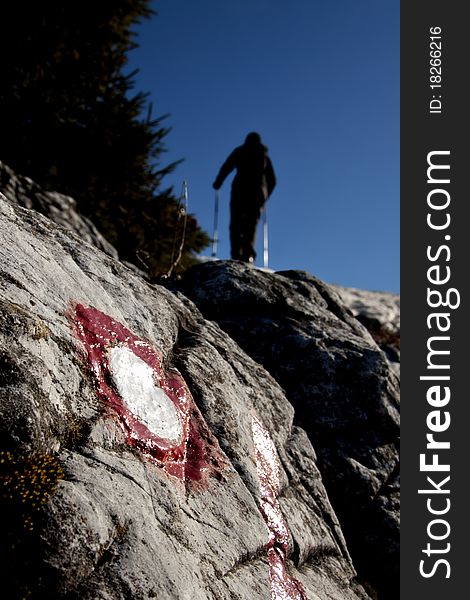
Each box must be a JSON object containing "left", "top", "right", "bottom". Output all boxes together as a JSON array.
[{"left": 0, "top": 161, "right": 118, "bottom": 258}]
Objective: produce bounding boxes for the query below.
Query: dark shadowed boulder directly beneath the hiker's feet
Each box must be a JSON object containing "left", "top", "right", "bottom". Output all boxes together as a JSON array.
[{"left": 181, "top": 261, "right": 400, "bottom": 600}]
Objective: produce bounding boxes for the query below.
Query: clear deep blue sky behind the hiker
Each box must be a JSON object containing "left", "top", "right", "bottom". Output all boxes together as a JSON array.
[{"left": 129, "top": 0, "right": 399, "bottom": 292}]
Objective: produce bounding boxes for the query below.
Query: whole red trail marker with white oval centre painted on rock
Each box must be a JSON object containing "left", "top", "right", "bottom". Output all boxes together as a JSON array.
[{"left": 71, "top": 304, "right": 223, "bottom": 481}]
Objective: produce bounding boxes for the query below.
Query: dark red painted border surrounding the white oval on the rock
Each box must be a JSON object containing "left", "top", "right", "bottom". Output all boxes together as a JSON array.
[{"left": 70, "top": 304, "right": 226, "bottom": 482}]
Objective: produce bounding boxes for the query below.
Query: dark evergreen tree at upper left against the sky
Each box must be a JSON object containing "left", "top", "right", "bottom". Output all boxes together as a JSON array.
[{"left": 0, "top": 0, "right": 209, "bottom": 274}]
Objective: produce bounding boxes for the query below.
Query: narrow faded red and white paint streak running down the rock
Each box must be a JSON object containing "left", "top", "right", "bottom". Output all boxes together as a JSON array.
[{"left": 251, "top": 414, "right": 308, "bottom": 600}]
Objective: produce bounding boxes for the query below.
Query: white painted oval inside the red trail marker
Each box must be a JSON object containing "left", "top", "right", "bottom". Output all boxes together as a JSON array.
[{"left": 108, "top": 346, "right": 183, "bottom": 442}]
